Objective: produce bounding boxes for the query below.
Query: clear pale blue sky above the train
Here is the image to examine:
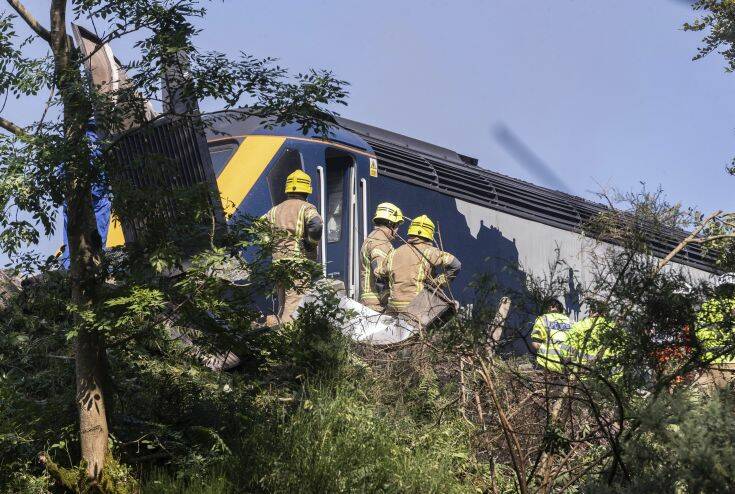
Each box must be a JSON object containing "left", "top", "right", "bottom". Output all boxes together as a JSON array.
[{"left": 0, "top": 0, "right": 735, "bottom": 261}]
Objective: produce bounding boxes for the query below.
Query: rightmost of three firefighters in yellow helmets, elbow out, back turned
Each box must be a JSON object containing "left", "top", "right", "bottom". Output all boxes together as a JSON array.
[{"left": 377, "top": 215, "right": 462, "bottom": 314}]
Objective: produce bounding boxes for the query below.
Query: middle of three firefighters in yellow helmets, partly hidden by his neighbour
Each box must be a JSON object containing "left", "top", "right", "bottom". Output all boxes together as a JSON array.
[{"left": 360, "top": 202, "right": 403, "bottom": 312}]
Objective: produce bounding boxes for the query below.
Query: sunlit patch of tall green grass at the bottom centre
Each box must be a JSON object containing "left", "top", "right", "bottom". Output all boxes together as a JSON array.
[{"left": 250, "top": 386, "right": 482, "bottom": 493}]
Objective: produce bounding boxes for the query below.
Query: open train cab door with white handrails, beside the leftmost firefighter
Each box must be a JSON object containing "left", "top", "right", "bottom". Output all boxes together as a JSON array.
[{"left": 317, "top": 148, "right": 360, "bottom": 298}]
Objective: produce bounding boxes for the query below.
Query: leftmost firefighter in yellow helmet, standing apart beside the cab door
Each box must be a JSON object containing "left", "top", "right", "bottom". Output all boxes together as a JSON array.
[{"left": 263, "top": 170, "right": 324, "bottom": 323}]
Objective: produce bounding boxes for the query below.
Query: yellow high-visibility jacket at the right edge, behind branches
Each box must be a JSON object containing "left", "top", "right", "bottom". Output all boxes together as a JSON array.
[{"left": 696, "top": 298, "right": 735, "bottom": 364}]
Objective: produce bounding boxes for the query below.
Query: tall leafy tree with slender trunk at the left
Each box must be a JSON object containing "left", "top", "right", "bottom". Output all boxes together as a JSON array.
[{"left": 0, "top": 0, "right": 346, "bottom": 482}]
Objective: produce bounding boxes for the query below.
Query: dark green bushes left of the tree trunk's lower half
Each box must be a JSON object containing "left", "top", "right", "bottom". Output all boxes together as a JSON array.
[{"left": 0, "top": 273, "right": 76, "bottom": 489}]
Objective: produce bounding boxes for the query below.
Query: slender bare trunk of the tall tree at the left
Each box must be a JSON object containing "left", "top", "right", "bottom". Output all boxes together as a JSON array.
[{"left": 50, "top": 0, "right": 108, "bottom": 481}]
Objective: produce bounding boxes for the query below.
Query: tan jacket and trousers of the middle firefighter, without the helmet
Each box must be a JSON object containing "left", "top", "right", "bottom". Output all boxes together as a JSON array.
[{"left": 360, "top": 225, "right": 393, "bottom": 306}]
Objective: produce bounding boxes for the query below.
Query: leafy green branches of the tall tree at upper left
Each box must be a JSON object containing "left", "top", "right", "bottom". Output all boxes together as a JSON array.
[{"left": 0, "top": 0, "right": 347, "bottom": 273}]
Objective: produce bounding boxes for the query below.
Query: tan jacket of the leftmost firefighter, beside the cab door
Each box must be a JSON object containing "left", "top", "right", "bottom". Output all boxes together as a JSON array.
[{"left": 263, "top": 198, "right": 322, "bottom": 260}]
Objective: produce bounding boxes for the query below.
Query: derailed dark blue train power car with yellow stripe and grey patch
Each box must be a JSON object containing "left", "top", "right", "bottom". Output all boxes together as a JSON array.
[{"left": 75, "top": 27, "right": 713, "bottom": 344}]
